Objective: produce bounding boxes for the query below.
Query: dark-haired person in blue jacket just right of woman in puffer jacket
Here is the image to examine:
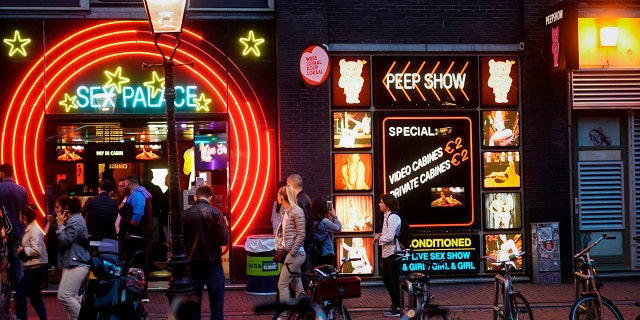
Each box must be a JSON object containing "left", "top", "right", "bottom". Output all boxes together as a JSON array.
[{"left": 310, "top": 196, "right": 342, "bottom": 268}]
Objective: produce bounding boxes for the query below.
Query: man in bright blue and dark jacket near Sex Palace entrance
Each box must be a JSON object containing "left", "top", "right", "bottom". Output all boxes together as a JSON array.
[{"left": 122, "top": 174, "right": 153, "bottom": 302}]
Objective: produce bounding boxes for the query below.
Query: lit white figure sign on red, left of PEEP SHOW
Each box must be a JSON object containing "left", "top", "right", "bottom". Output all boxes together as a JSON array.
[{"left": 331, "top": 56, "right": 371, "bottom": 107}]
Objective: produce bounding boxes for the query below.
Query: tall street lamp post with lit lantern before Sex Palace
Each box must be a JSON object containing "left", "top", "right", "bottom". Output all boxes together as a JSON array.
[{"left": 143, "top": 0, "right": 193, "bottom": 303}]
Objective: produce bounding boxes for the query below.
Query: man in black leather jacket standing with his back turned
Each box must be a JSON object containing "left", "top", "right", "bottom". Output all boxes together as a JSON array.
[{"left": 182, "top": 186, "right": 229, "bottom": 320}]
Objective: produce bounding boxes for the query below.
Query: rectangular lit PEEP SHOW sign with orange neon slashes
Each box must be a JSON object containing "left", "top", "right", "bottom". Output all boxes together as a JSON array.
[{"left": 372, "top": 57, "right": 478, "bottom": 107}]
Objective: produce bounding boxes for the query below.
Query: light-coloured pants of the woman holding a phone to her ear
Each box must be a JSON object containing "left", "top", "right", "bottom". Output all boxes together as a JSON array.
[{"left": 58, "top": 266, "right": 89, "bottom": 320}]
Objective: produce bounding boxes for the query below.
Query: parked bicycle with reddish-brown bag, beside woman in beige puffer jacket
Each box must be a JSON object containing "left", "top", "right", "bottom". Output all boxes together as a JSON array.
[{"left": 274, "top": 258, "right": 362, "bottom": 320}]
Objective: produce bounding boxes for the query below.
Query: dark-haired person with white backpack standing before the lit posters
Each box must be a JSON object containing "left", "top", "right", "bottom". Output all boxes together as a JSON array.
[{"left": 373, "top": 193, "right": 402, "bottom": 317}]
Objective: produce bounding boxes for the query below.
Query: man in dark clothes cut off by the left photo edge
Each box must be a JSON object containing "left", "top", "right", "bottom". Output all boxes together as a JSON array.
[{"left": 0, "top": 163, "right": 29, "bottom": 289}]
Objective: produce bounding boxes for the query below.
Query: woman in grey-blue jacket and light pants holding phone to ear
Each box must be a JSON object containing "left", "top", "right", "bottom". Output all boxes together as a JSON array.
[{"left": 54, "top": 196, "right": 91, "bottom": 320}]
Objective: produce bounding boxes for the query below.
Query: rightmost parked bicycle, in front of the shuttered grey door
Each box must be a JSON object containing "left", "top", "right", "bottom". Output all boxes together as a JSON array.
[{"left": 569, "top": 234, "right": 623, "bottom": 320}]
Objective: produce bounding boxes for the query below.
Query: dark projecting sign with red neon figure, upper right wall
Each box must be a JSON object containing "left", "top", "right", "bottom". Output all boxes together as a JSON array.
[{"left": 543, "top": 1, "right": 579, "bottom": 73}]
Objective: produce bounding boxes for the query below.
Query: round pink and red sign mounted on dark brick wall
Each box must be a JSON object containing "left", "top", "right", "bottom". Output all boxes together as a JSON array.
[{"left": 300, "top": 44, "right": 331, "bottom": 87}]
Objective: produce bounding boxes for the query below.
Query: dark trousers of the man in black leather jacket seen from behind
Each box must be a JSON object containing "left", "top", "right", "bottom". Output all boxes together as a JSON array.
[{"left": 187, "top": 260, "right": 224, "bottom": 320}]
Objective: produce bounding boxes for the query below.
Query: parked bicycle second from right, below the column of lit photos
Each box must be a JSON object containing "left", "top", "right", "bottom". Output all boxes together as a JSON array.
[{"left": 480, "top": 252, "right": 533, "bottom": 320}]
